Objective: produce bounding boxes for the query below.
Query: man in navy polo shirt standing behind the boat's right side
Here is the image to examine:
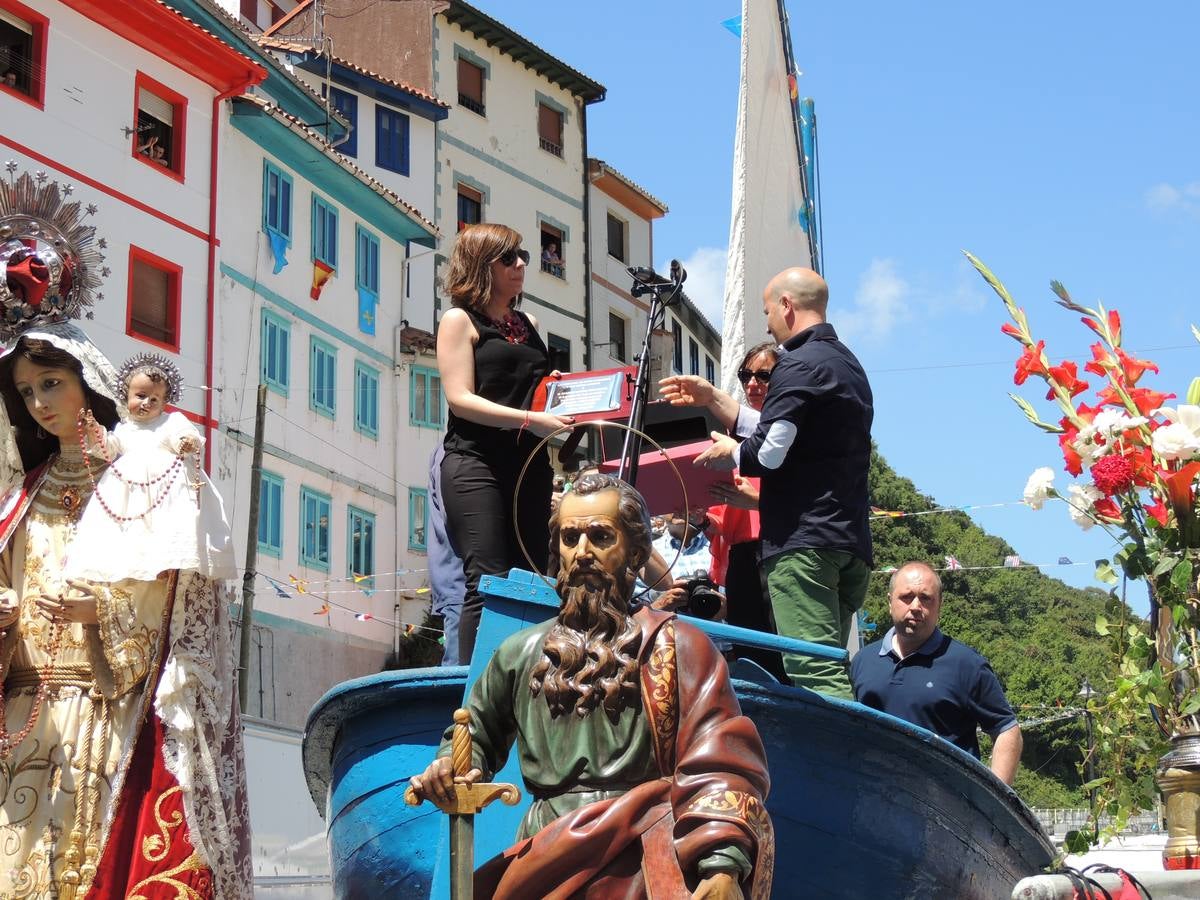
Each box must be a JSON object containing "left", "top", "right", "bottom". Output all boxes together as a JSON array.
[{"left": 851, "top": 563, "right": 1024, "bottom": 785}]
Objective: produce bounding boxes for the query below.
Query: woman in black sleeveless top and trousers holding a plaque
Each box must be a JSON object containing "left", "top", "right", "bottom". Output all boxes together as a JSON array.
[{"left": 438, "top": 224, "right": 572, "bottom": 665}]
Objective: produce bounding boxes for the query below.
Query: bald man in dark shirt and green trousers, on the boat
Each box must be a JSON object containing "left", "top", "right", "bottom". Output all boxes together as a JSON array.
[{"left": 696, "top": 269, "right": 874, "bottom": 698}]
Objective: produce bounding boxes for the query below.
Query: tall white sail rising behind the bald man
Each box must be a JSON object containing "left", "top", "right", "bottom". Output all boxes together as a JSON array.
[{"left": 721, "top": 0, "right": 812, "bottom": 397}]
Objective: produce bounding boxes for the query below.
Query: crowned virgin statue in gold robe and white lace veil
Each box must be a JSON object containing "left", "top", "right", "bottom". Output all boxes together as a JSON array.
[{"left": 0, "top": 173, "right": 252, "bottom": 900}]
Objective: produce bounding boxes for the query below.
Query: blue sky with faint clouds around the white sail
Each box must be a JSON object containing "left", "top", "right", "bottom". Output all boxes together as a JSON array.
[{"left": 479, "top": 0, "right": 1200, "bottom": 606}]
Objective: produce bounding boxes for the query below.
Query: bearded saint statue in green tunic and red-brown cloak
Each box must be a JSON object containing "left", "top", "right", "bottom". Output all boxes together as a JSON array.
[{"left": 412, "top": 475, "right": 774, "bottom": 900}]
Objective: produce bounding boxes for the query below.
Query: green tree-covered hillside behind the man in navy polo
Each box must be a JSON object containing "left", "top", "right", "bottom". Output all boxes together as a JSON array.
[{"left": 864, "top": 452, "right": 1116, "bottom": 806}]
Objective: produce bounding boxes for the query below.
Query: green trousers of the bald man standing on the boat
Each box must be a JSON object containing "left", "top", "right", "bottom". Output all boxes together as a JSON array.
[{"left": 763, "top": 550, "right": 871, "bottom": 700}]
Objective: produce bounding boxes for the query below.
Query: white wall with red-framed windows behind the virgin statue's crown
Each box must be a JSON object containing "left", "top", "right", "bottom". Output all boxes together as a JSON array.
[{"left": 0, "top": 0, "right": 215, "bottom": 427}]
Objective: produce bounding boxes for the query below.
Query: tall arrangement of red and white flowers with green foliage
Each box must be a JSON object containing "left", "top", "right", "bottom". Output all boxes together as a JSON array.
[{"left": 966, "top": 253, "right": 1200, "bottom": 850}]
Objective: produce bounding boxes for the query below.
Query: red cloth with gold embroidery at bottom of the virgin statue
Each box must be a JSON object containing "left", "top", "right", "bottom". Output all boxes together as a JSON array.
[{"left": 86, "top": 713, "right": 215, "bottom": 900}]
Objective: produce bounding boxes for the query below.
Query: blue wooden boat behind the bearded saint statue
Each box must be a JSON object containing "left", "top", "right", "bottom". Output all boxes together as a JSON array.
[{"left": 304, "top": 572, "right": 1054, "bottom": 900}]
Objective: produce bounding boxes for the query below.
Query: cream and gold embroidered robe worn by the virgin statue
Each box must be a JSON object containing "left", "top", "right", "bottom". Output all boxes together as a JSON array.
[{"left": 0, "top": 455, "right": 176, "bottom": 898}]
